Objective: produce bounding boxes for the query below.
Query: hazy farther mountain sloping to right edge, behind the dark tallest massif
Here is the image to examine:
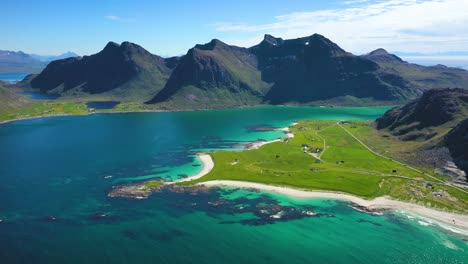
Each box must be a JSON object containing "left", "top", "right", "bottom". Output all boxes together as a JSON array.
[{"left": 361, "top": 49, "right": 468, "bottom": 89}]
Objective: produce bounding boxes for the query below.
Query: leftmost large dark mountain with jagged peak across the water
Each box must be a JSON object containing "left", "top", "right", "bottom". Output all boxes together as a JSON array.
[{"left": 30, "top": 42, "right": 176, "bottom": 100}]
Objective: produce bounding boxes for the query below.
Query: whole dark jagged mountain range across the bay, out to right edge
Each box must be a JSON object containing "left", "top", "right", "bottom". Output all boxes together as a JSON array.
[{"left": 18, "top": 34, "right": 468, "bottom": 109}]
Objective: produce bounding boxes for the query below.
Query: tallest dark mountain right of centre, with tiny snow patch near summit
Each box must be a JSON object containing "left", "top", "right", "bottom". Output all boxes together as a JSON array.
[{"left": 250, "top": 34, "right": 419, "bottom": 104}]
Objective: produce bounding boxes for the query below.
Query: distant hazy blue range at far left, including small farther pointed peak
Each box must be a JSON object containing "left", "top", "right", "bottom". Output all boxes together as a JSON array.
[{"left": 0, "top": 50, "right": 78, "bottom": 73}]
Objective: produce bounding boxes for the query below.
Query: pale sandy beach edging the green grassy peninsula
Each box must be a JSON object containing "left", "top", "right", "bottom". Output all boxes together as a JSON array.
[{"left": 186, "top": 150, "right": 468, "bottom": 232}]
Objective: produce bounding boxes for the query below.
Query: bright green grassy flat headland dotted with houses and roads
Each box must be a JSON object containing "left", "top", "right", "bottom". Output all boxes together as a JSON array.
[{"left": 190, "top": 121, "right": 468, "bottom": 213}]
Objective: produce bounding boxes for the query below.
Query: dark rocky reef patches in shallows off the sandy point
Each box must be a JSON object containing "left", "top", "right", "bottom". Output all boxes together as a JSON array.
[{"left": 109, "top": 183, "right": 321, "bottom": 225}]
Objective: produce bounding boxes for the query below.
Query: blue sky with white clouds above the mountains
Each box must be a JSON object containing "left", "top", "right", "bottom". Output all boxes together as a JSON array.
[{"left": 0, "top": 0, "right": 468, "bottom": 65}]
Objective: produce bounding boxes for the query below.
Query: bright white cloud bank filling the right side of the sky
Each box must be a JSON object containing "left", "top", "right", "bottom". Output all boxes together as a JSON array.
[{"left": 216, "top": 0, "right": 468, "bottom": 53}]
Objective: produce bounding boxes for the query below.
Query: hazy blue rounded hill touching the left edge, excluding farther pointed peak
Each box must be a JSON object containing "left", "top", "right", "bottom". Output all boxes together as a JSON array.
[{"left": 0, "top": 50, "right": 47, "bottom": 73}]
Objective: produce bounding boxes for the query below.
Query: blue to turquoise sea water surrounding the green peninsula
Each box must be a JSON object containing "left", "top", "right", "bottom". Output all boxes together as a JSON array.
[{"left": 0, "top": 107, "right": 468, "bottom": 263}]
